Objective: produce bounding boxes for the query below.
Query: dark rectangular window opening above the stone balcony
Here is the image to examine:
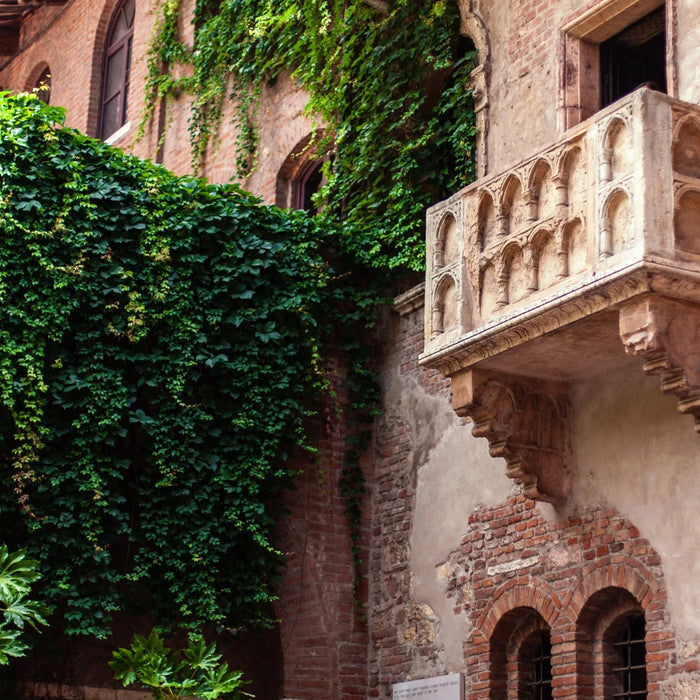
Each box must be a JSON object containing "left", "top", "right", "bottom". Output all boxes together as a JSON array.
[{"left": 600, "top": 6, "right": 666, "bottom": 107}]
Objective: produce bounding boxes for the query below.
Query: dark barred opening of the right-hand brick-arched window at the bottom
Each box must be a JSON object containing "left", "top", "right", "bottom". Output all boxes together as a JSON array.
[{"left": 606, "top": 612, "right": 647, "bottom": 700}]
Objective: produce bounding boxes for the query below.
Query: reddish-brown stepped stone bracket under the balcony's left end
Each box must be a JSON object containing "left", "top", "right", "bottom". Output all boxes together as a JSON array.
[{"left": 452, "top": 369, "right": 572, "bottom": 502}]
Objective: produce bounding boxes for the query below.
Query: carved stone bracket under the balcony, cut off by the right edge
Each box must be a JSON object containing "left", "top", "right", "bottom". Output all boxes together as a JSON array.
[{"left": 620, "top": 294, "right": 700, "bottom": 433}]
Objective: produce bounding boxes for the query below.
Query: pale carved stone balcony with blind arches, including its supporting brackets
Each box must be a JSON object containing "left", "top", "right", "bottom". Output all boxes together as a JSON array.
[{"left": 421, "top": 88, "right": 700, "bottom": 501}]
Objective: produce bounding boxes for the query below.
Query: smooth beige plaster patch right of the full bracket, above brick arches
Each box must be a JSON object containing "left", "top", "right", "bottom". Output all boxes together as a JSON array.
[{"left": 572, "top": 366, "right": 700, "bottom": 644}]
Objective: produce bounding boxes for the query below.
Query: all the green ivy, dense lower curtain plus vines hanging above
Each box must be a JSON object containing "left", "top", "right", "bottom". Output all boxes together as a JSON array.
[{"left": 0, "top": 0, "right": 475, "bottom": 652}]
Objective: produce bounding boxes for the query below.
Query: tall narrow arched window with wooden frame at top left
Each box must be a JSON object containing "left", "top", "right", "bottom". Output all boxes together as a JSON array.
[{"left": 100, "top": 0, "right": 135, "bottom": 139}]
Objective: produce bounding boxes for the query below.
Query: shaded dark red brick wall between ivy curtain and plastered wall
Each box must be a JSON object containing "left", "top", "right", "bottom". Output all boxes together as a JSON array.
[{"left": 276, "top": 357, "right": 372, "bottom": 700}]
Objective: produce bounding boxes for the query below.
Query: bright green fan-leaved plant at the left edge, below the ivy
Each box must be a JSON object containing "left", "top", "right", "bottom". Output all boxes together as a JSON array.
[{"left": 0, "top": 544, "right": 47, "bottom": 666}]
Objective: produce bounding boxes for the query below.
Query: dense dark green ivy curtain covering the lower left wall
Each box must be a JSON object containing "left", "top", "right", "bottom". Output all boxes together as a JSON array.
[{"left": 0, "top": 95, "right": 356, "bottom": 637}]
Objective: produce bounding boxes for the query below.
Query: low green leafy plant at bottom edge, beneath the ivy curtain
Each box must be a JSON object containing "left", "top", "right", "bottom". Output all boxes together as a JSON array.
[{"left": 109, "top": 629, "right": 252, "bottom": 700}]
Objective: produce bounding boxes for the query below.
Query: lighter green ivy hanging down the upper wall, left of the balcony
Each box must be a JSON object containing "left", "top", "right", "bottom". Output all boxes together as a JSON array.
[{"left": 144, "top": 0, "right": 476, "bottom": 270}]
